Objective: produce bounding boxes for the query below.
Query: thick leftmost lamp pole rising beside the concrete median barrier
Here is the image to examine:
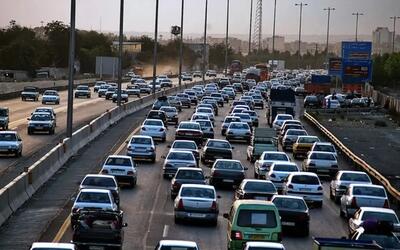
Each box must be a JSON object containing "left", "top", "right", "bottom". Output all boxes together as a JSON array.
[{"left": 67, "top": 0, "right": 76, "bottom": 138}]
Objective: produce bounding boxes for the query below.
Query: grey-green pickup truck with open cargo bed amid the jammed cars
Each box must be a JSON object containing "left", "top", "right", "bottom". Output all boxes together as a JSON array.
[{"left": 247, "top": 128, "right": 278, "bottom": 162}]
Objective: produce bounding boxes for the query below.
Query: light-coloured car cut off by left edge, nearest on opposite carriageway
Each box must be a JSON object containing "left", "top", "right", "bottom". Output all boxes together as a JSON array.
[{"left": 0, "top": 131, "right": 22, "bottom": 157}]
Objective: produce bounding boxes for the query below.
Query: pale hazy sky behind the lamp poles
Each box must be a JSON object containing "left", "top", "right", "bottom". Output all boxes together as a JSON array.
[{"left": 0, "top": 0, "right": 400, "bottom": 35}]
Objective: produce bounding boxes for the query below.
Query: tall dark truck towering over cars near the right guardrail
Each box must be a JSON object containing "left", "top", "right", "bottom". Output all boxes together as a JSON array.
[{"left": 266, "top": 88, "right": 296, "bottom": 127}]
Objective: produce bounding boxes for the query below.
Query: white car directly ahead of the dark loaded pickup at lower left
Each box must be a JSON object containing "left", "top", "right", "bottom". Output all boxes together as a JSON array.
[{"left": 79, "top": 174, "right": 120, "bottom": 205}]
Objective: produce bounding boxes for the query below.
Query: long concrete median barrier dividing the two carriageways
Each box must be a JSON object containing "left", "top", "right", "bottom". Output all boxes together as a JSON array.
[{"left": 0, "top": 82, "right": 206, "bottom": 225}]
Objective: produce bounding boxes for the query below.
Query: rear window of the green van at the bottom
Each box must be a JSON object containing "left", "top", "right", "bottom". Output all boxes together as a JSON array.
[{"left": 237, "top": 209, "right": 277, "bottom": 228}]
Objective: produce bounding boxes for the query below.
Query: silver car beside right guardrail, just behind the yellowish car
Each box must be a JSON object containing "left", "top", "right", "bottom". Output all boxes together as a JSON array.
[{"left": 302, "top": 151, "right": 339, "bottom": 177}]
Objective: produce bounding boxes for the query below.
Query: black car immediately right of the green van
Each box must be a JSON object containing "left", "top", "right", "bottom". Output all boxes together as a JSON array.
[{"left": 271, "top": 195, "right": 310, "bottom": 236}]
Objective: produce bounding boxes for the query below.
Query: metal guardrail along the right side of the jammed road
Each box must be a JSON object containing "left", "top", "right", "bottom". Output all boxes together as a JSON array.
[{"left": 304, "top": 112, "right": 400, "bottom": 205}]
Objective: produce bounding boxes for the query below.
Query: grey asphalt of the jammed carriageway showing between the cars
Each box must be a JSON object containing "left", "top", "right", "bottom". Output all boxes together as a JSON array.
[{"left": 45, "top": 94, "right": 349, "bottom": 250}]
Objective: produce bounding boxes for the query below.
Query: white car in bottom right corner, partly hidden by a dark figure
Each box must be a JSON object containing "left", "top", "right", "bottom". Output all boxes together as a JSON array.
[{"left": 349, "top": 207, "right": 400, "bottom": 235}]
